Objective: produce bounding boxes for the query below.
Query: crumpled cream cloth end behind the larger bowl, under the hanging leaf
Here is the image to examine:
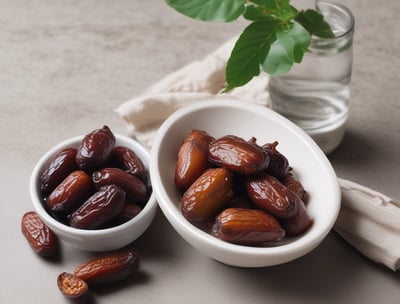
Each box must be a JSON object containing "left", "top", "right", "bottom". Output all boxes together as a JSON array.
[{"left": 116, "top": 38, "right": 270, "bottom": 146}]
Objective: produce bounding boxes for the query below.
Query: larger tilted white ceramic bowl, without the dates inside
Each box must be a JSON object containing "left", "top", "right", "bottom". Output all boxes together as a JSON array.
[{"left": 150, "top": 99, "right": 340, "bottom": 267}]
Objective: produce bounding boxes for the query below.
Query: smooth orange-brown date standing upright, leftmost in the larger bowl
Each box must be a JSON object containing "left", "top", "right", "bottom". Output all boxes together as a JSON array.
[{"left": 175, "top": 130, "right": 214, "bottom": 190}]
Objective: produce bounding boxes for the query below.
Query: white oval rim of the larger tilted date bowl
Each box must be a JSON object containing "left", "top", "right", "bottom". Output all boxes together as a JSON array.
[{"left": 150, "top": 98, "right": 341, "bottom": 260}]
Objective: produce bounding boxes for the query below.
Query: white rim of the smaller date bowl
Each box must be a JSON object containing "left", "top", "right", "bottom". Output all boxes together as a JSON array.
[{"left": 29, "top": 133, "right": 157, "bottom": 238}]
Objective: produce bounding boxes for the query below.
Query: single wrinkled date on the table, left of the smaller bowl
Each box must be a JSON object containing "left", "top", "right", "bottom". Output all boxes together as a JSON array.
[{"left": 21, "top": 211, "right": 59, "bottom": 256}]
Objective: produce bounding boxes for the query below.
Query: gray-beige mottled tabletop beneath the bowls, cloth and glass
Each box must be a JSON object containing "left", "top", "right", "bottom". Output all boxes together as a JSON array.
[{"left": 0, "top": 0, "right": 400, "bottom": 304}]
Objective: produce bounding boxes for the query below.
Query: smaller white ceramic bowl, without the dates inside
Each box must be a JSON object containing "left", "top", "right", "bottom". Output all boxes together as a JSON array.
[{"left": 29, "top": 134, "right": 157, "bottom": 251}]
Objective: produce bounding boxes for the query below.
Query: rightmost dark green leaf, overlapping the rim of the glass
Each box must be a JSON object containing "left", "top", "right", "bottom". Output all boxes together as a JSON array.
[{"left": 295, "top": 9, "right": 335, "bottom": 38}]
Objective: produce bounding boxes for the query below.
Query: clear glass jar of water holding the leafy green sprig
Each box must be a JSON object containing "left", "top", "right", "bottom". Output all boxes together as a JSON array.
[{"left": 269, "top": 1, "right": 354, "bottom": 153}]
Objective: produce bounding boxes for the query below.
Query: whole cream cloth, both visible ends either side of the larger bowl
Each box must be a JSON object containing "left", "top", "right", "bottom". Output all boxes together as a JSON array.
[{"left": 116, "top": 38, "right": 400, "bottom": 270}]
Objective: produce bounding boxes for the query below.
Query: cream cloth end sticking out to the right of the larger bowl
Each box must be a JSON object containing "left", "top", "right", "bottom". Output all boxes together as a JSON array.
[{"left": 334, "top": 178, "right": 400, "bottom": 270}]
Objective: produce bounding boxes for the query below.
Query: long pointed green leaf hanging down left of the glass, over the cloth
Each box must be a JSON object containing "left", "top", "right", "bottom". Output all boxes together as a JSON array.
[{"left": 225, "top": 18, "right": 279, "bottom": 91}]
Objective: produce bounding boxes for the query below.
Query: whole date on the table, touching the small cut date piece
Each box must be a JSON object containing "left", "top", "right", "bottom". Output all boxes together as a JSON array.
[{"left": 74, "top": 251, "right": 139, "bottom": 285}]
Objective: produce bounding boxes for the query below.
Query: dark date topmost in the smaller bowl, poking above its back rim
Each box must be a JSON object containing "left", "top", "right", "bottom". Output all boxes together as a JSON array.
[{"left": 76, "top": 126, "right": 115, "bottom": 171}]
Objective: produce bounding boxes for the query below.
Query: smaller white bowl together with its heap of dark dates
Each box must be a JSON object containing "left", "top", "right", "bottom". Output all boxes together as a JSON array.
[{"left": 30, "top": 126, "right": 157, "bottom": 251}]
